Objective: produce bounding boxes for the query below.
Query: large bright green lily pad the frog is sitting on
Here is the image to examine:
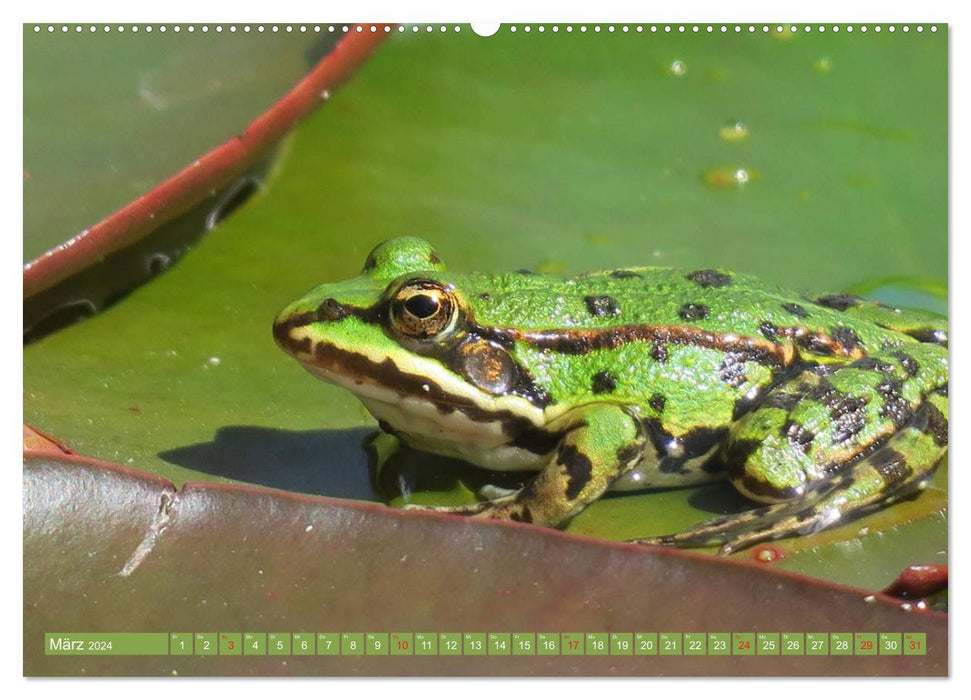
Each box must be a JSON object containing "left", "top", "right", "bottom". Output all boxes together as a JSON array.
[{"left": 24, "top": 28, "right": 947, "bottom": 586}]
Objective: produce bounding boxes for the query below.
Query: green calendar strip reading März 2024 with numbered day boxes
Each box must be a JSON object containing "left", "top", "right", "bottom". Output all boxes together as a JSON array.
[{"left": 44, "top": 631, "right": 927, "bottom": 657}]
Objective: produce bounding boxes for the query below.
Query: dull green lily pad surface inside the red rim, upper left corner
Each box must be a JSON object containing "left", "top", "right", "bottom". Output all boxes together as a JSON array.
[{"left": 24, "top": 24, "right": 338, "bottom": 262}]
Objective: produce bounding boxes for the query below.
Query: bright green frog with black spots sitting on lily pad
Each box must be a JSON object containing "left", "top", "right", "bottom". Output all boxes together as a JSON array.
[{"left": 273, "top": 238, "right": 948, "bottom": 554}]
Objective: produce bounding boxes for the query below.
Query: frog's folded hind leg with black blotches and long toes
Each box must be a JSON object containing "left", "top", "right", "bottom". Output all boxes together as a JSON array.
[{"left": 637, "top": 344, "right": 947, "bottom": 554}]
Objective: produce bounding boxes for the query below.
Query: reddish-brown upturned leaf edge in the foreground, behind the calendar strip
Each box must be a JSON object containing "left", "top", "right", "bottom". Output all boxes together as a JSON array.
[{"left": 24, "top": 454, "right": 948, "bottom": 676}]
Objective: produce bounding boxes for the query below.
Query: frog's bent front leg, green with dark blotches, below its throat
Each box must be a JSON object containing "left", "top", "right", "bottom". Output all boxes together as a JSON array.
[{"left": 408, "top": 403, "right": 647, "bottom": 527}]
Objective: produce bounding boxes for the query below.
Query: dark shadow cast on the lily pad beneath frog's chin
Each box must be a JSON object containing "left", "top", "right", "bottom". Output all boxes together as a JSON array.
[{"left": 158, "top": 425, "right": 376, "bottom": 500}]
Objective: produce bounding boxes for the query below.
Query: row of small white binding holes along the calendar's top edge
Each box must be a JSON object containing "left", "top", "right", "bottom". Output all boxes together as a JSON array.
[{"left": 34, "top": 24, "right": 937, "bottom": 34}]
